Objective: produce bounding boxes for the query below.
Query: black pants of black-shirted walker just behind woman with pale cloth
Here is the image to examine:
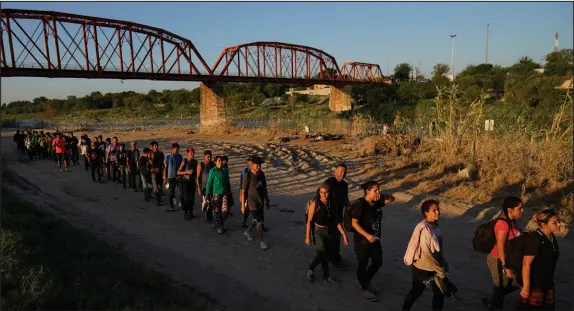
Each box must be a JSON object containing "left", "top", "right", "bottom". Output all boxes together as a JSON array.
[{"left": 354, "top": 239, "right": 383, "bottom": 289}]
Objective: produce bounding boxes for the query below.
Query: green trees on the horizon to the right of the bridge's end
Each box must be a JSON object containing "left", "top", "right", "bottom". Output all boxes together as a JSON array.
[{"left": 358, "top": 49, "right": 574, "bottom": 107}]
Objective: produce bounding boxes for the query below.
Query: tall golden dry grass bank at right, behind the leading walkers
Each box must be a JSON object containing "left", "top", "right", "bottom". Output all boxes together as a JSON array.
[{"left": 413, "top": 88, "right": 574, "bottom": 222}]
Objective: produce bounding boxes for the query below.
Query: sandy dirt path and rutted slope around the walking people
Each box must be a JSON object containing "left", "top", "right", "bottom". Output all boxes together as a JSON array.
[{"left": 1, "top": 130, "right": 574, "bottom": 311}]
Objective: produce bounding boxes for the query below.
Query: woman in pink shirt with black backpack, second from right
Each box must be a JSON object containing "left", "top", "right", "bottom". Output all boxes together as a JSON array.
[{"left": 482, "top": 197, "right": 523, "bottom": 310}]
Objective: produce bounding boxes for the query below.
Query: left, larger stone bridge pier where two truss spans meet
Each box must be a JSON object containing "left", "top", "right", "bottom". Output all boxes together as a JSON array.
[{"left": 199, "top": 82, "right": 225, "bottom": 127}]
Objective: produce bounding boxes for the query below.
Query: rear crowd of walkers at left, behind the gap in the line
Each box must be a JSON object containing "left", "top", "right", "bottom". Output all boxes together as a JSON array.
[{"left": 14, "top": 130, "right": 270, "bottom": 250}]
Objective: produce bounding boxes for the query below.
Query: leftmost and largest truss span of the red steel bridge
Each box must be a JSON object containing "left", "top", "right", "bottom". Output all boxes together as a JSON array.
[{"left": 0, "top": 9, "right": 212, "bottom": 80}]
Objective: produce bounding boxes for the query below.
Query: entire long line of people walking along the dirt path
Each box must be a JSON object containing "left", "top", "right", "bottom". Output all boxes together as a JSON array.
[{"left": 14, "top": 130, "right": 561, "bottom": 311}]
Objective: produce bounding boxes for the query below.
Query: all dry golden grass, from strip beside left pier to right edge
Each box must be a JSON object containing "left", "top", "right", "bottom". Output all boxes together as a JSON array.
[{"left": 196, "top": 86, "right": 574, "bottom": 222}]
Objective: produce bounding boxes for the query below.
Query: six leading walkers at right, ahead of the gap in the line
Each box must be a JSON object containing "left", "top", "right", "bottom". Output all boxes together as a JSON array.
[{"left": 305, "top": 163, "right": 561, "bottom": 311}]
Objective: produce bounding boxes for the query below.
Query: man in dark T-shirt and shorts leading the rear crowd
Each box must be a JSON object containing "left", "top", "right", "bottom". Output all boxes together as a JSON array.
[{"left": 240, "top": 157, "right": 269, "bottom": 250}]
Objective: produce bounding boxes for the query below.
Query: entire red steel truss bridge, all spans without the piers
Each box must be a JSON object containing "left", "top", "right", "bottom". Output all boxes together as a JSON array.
[{"left": 0, "top": 9, "right": 385, "bottom": 86}]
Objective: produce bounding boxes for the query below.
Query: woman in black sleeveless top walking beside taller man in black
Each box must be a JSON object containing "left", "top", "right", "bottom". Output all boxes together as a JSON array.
[{"left": 305, "top": 183, "right": 349, "bottom": 284}]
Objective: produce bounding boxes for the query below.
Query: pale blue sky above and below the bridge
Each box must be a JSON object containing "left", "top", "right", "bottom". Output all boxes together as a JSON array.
[{"left": 1, "top": 2, "right": 574, "bottom": 103}]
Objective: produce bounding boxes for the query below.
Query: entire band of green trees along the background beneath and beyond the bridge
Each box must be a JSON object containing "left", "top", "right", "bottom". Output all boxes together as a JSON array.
[{"left": 2, "top": 49, "right": 574, "bottom": 118}]
